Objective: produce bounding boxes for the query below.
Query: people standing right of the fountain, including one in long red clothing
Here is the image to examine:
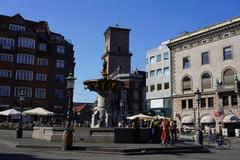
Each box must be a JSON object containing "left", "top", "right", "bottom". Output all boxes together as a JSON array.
[{"left": 132, "top": 118, "right": 177, "bottom": 145}]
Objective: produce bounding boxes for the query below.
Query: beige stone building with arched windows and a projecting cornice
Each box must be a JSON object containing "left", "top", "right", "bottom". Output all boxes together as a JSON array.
[{"left": 168, "top": 17, "right": 240, "bottom": 135}]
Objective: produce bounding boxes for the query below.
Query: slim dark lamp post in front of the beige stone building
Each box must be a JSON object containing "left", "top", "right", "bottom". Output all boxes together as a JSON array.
[{"left": 194, "top": 89, "right": 203, "bottom": 145}]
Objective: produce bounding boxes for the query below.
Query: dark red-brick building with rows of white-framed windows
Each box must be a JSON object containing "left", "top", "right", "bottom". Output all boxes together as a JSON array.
[{"left": 0, "top": 14, "right": 75, "bottom": 113}]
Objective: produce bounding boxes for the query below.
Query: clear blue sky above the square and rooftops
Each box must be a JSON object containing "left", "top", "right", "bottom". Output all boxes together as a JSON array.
[{"left": 0, "top": 0, "right": 240, "bottom": 102}]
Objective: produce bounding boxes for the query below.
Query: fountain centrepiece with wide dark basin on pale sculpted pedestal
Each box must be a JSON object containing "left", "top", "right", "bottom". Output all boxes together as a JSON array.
[{"left": 83, "top": 60, "right": 124, "bottom": 128}]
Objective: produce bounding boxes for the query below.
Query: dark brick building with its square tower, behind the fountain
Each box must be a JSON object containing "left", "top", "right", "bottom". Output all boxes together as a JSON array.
[{"left": 102, "top": 26, "right": 146, "bottom": 125}]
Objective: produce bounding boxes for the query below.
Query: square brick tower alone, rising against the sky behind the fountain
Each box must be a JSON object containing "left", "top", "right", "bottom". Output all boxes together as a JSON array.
[{"left": 102, "top": 27, "right": 132, "bottom": 78}]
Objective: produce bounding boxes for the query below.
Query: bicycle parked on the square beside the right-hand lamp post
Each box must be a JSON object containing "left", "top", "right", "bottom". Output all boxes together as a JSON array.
[{"left": 208, "top": 135, "right": 231, "bottom": 149}]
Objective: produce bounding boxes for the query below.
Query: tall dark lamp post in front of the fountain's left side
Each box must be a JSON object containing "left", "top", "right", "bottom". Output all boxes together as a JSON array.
[{"left": 62, "top": 73, "right": 76, "bottom": 150}]
